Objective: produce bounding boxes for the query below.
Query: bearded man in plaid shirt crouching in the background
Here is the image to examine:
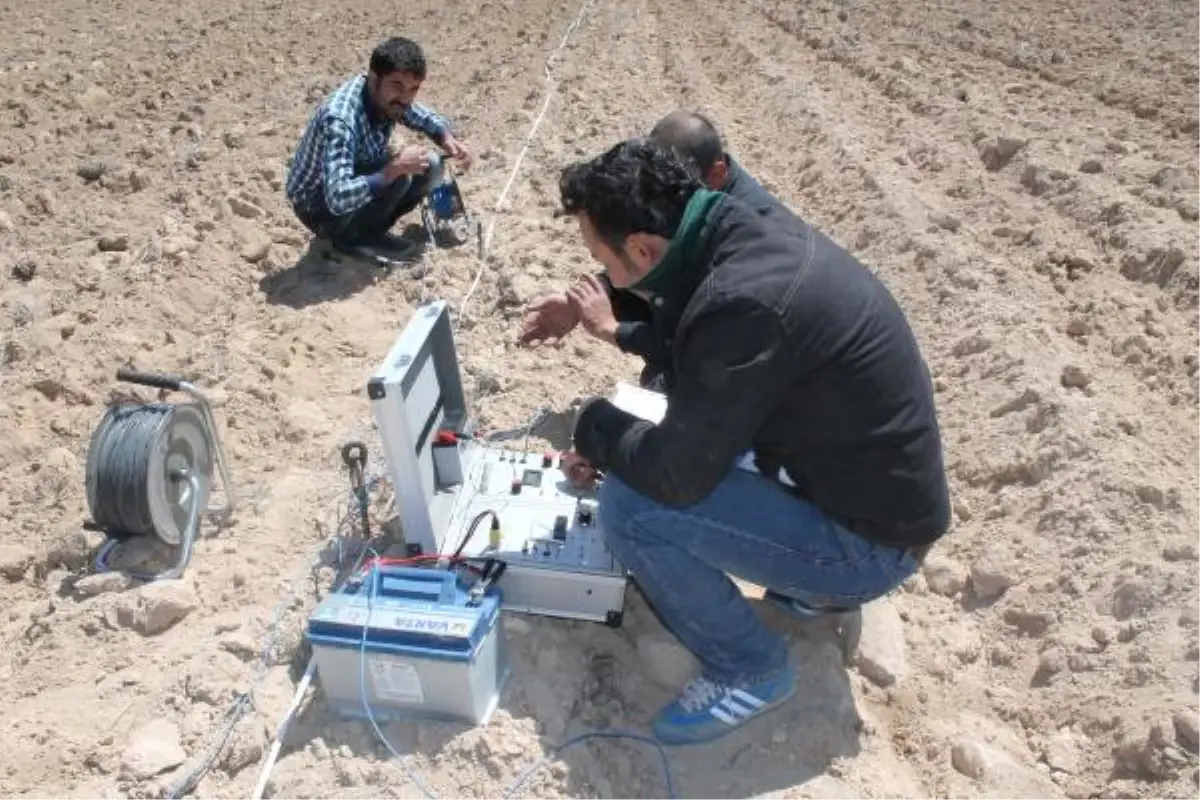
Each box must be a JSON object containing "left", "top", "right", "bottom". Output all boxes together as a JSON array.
[{"left": 287, "top": 37, "right": 470, "bottom": 260}]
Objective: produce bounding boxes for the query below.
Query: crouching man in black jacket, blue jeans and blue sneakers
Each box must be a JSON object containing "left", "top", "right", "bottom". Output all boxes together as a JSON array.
[{"left": 559, "top": 139, "right": 950, "bottom": 744}]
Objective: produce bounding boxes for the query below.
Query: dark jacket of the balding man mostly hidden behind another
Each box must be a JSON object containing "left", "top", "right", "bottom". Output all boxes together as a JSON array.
[{"left": 598, "top": 154, "right": 805, "bottom": 384}]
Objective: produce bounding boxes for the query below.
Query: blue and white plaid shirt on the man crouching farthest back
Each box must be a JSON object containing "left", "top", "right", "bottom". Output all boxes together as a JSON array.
[{"left": 287, "top": 74, "right": 449, "bottom": 217}]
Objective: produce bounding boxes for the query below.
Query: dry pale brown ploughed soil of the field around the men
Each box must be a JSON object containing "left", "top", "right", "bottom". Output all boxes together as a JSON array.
[{"left": 0, "top": 0, "right": 1200, "bottom": 800}]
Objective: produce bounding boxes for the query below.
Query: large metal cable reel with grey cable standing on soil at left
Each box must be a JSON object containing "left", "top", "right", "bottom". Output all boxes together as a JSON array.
[{"left": 86, "top": 367, "right": 234, "bottom": 581}]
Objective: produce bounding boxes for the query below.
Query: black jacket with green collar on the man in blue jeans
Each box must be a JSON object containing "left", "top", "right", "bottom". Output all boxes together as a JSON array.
[{"left": 575, "top": 196, "right": 949, "bottom": 546}]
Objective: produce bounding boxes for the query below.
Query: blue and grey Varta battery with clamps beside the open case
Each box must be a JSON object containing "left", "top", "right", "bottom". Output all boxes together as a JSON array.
[{"left": 307, "top": 564, "right": 509, "bottom": 724}]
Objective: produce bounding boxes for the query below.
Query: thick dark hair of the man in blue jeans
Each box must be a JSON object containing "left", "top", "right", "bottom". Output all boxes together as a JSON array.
[{"left": 558, "top": 138, "right": 702, "bottom": 253}]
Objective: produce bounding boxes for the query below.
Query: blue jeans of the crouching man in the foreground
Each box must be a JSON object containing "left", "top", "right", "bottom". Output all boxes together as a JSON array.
[{"left": 599, "top": 469, "right": 920, "bottom": 685}]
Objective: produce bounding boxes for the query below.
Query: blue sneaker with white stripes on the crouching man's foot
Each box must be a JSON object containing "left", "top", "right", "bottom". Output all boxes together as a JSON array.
[{"left": 652, "top": 666, "right": 796, "bottom": 745}]
